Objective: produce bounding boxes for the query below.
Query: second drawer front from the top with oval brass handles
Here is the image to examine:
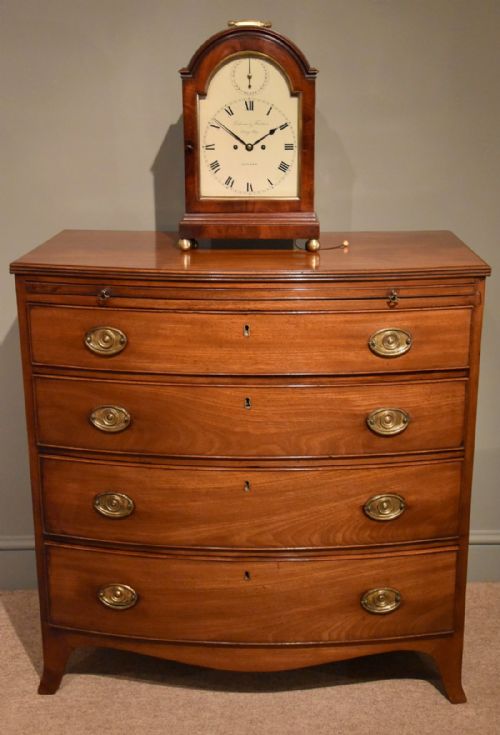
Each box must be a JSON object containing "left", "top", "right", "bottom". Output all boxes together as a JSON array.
[{"left": 35, "top": 377, "right": 466, "bottom": 457}]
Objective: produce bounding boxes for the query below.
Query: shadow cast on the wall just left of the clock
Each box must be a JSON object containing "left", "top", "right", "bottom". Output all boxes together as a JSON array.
[{"left": 151, "top": 117, "right": 184, "bottom": 232}]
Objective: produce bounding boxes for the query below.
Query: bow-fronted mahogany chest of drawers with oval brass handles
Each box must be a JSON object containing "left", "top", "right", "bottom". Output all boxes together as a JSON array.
[{"left": 11, "top": 231, "right": 489, "bottom": 702}]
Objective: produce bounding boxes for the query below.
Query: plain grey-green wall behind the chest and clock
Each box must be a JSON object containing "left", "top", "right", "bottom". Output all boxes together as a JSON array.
[{"left": 0, "top": 0, "right": 500, "bottom": 587}]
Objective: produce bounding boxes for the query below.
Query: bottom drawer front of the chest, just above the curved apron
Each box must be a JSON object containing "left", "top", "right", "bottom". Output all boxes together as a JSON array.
[{"left": 47, "top": 546, "right": 456, "bottom": 643}]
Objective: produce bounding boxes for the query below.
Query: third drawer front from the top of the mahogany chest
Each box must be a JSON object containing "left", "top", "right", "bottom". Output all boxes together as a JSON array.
[{"left": 42, "top": 458, "right": 461, "bottom": 549}]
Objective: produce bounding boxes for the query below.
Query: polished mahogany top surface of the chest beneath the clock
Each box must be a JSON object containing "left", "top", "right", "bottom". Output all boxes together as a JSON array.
[{"left": 11, "top": 230, "right": 490, "bottom": 281}]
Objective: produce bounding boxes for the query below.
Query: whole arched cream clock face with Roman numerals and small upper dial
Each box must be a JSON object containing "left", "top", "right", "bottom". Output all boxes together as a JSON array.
[{"left": 198, "top": 54, "right": 300, "bottom": 199}]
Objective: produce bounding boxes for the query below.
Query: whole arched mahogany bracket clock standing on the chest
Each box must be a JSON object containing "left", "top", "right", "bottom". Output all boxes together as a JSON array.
[{"left": 179, "top": 21, "right": 319, "bottom": 250}]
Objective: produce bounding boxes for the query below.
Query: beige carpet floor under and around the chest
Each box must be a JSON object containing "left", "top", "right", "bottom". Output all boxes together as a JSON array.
[{"left": 0, "top": 583, "right": 500, "bottom": 735}]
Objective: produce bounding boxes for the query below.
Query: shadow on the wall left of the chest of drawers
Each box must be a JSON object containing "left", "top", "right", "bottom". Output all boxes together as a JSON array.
[{"left": 0, "top": 319, "right": 32, "bottom": 536}]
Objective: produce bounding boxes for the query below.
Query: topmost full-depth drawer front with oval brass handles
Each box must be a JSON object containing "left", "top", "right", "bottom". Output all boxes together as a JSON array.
[{"left": 30, "top": 306, "right": 470, "bottom": 375}]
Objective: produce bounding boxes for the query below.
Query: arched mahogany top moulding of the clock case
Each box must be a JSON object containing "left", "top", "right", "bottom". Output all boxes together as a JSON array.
[{"left": 180, "top": 26, "right": 317, "bottom": 95}]
